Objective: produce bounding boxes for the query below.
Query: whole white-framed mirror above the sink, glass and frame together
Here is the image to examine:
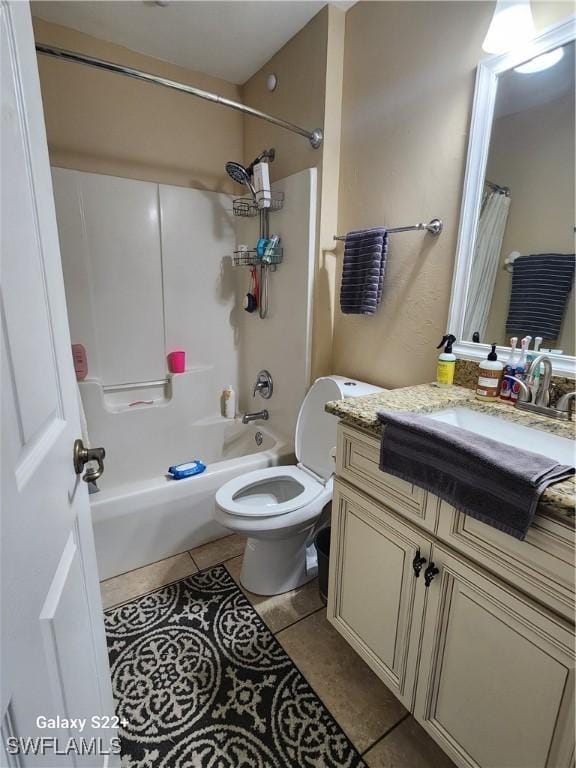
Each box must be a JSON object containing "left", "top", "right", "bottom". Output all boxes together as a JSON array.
[{"left": 449, "top": 20, "right": 576, "bottom": 370}]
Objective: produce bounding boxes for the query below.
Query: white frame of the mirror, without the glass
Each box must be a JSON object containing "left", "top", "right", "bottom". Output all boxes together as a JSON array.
[{"left": 448, "top": 17, "right": 576, "bottom": 376}]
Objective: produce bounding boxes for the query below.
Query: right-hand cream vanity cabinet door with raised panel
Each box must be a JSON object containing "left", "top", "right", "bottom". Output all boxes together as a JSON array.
[{"left": 414, "top": 545, "right": 574, "bottom": 768}]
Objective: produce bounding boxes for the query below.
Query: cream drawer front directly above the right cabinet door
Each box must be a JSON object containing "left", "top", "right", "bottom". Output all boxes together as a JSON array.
[{"left": 436, "top": 501, "right": 575, "bottom": 621}]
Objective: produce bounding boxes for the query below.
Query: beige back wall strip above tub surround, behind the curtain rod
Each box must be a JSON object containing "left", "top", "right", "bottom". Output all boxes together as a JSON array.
[{"left": 34, "top": 19, "right": 244, "bottom": 191}]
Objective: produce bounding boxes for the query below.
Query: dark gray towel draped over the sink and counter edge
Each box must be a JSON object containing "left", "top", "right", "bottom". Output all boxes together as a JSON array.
[{"left": 378, "top": 412, "right": 574, "bottom": 540}]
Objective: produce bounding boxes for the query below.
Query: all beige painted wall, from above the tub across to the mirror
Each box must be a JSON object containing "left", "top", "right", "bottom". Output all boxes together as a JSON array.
[{"left": 34, "top": 0, "right": 572, "bottom": 386}]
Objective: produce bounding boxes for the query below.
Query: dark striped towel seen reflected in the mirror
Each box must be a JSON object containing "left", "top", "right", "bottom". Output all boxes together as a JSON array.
[{"left": 506, "top": 253, "right": 576, "bottom": 340}]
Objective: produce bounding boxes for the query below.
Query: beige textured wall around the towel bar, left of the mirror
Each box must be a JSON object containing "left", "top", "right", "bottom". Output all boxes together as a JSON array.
[{"left": 334, "top": 2, "right": 494, "bottom": 387}]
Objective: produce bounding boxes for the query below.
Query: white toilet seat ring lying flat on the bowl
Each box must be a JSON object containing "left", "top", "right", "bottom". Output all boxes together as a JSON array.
[{"left": 216, "top": 465, "right": 325, "bottom": 518}]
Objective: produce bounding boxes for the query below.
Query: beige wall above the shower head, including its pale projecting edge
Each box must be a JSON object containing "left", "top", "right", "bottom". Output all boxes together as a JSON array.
[{"left": 242, "top": 6, "right": 345, "bottom": 378}]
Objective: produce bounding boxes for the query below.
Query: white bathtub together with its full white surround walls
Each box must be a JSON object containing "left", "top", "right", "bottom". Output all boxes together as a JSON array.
[{"left": 53, "top": 165, "right": 316, "bottom": 578}]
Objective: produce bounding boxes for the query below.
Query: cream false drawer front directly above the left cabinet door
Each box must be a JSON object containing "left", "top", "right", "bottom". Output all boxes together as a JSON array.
[{"left": 336, "top": 424, "right": 439, "bottom": 531}]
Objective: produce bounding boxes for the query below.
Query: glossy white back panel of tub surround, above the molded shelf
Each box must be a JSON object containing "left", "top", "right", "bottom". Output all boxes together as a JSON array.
[{"left": 52, "top": 168, "right": 239, "bottom": 396}]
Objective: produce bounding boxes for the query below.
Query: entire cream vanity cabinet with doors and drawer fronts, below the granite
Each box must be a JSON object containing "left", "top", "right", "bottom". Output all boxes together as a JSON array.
[{"left": 328, "top": 425, "right": 574, "bottom": 768}]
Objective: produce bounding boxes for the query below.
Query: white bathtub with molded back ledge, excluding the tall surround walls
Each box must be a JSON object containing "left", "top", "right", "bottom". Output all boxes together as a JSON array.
[{"left": 80, "top": 367, "right": 292, "bottom": 579}]
